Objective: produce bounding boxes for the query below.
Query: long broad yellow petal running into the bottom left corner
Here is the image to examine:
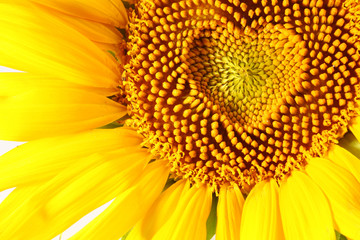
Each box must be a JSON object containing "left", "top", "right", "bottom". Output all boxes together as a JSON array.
[{"left": 0, "top": 149, "right": 150, "bottom": 239}]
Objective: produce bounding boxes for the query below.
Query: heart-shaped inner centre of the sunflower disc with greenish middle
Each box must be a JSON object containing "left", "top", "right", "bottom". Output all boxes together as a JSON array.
[{"left": 187, "top": 24, "right": 304, "bottom": 131}]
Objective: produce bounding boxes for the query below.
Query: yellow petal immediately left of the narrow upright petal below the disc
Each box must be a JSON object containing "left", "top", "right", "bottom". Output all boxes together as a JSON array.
[{"left": 152, "top": 185, "right": 212, "bottom": 240}]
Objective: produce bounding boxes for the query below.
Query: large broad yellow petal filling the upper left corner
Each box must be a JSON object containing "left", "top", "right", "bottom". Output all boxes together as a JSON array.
[{"left": 0, "top": 1, "right": 121, "bottom": 88}]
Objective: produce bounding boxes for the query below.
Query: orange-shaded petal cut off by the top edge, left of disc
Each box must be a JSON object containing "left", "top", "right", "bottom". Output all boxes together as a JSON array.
[{"left": 31, "top": 0, "right": 127, "bottom": 28}]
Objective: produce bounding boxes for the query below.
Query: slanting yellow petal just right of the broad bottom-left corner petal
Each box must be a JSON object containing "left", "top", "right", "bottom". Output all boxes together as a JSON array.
[{"left": 71, "top": 161, "right": 170, "bottom": 240}]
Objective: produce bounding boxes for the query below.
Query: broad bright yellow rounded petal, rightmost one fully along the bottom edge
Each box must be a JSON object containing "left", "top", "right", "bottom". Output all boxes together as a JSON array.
[{"left": 280, "top": 171, "right": 335, "bottom": 240}]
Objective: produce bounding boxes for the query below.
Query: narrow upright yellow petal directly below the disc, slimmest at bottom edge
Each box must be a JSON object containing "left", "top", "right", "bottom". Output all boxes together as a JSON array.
[{"left": 216, "top": 185, "right": 244, "bottom": 240}]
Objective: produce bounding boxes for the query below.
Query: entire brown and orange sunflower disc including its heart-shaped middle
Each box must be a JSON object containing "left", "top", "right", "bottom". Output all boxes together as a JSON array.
[{"left": 125, "top": 0, "right": 360, "bottom": 192}]
